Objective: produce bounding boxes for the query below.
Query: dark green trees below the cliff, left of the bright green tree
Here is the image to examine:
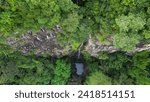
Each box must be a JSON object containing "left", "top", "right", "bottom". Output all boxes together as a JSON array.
[{"left": 0, "top": 53, "right": 54, "bottom": 85}]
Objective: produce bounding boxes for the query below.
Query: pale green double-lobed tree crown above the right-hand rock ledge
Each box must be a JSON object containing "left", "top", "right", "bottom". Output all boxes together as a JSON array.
[{"left": 114, "top": 14, "right": 146, "bottom": 51}]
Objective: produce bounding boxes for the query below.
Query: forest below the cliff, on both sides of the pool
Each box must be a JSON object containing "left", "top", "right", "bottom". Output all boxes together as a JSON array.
[{"left": 0, "top": 51, "right": 150, "bottom": 85}]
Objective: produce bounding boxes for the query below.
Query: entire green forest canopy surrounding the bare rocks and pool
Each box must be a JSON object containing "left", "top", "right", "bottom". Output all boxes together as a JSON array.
[{"left": 0, "top": 0, "right": 150, "bottom": 84}]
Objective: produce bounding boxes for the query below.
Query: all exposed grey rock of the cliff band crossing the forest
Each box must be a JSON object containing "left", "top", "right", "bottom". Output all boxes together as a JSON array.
[{"left": 7, "top": 25, "right": 150, "bottom": 57}]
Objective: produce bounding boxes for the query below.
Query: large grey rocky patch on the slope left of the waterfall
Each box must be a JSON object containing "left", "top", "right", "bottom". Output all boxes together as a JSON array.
[{"left": 7, "top": 25, "right": 68, "bottom": 56}]
